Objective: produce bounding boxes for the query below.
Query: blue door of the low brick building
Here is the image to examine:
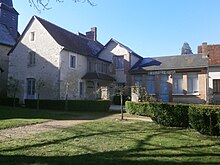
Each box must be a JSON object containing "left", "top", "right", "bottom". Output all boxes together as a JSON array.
[{"left": 159, "top": 75, "right": 170, "bottom": 102}]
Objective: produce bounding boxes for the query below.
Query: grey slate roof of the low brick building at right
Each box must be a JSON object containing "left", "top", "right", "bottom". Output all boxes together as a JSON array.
[{"left": 130, "top": 54, "right": 208, "bottom": 73}]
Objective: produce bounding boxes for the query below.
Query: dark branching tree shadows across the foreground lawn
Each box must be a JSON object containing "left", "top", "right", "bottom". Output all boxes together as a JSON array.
[{"left": 0, "top": 126, "right": 220, "bottom": 165}]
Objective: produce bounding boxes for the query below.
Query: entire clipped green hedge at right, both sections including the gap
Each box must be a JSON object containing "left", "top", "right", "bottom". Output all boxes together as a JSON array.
[{"left": 126, "top": 101, "right": 220, "bottom": 136}]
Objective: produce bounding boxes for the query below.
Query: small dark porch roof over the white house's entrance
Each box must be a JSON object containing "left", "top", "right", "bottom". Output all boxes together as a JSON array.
[{"left": 82, "top": 72, "right": 115, "bottom": 81}]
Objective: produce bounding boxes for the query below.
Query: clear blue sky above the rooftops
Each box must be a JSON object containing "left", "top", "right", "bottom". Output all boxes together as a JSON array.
[{"left": 13, "top": 0, "right": 220, "bottom": 57}]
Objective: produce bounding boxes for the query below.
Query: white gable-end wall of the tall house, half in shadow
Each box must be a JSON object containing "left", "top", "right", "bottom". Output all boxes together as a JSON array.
[{"left": 9, "top": 19, "right": 61, "bottom": 100}]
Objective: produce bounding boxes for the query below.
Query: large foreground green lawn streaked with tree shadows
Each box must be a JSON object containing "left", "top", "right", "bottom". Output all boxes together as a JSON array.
[{"left": 0, "top": 107, "right": 220, "bottom": 165}]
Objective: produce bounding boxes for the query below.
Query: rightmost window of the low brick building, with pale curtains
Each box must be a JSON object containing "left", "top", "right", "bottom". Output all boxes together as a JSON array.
[{"left": 187, "top": 73, "right": 199, "bottom": 94}]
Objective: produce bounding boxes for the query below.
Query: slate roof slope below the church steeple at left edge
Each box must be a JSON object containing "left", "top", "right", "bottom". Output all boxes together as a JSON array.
[{"left": 0, "top": 24, "right": 16, "bottom": 46}]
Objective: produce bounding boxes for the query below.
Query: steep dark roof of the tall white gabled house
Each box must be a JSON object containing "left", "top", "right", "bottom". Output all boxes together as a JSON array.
[{"left": 35, "top": 16, "right": 103, "bottom": 56}]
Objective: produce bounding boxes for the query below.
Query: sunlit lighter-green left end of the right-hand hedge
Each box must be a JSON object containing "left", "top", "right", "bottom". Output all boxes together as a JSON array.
[{"left": 126, "top": 101, "right": 153, "bottom": 117}]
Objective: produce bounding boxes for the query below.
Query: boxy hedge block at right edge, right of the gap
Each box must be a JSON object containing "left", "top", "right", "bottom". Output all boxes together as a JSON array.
[{"left": 189, "top": 105, "right": 220, "bottom": 136}]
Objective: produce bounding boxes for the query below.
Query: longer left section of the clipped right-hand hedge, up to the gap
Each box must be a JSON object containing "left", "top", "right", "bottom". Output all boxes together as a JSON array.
[{"left": 126, "top": 102, "right": 189, "bottom": 127}]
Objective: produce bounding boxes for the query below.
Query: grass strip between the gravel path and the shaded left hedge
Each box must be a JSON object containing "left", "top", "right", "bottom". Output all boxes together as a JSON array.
[{"left": 0, "top": 106, "right": 113, "bottom": 129}]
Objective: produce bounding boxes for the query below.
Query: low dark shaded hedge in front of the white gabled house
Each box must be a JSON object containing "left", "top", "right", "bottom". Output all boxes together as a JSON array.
[{"left": 25, "top": 100, "right": 111, "bottom": 112}]
